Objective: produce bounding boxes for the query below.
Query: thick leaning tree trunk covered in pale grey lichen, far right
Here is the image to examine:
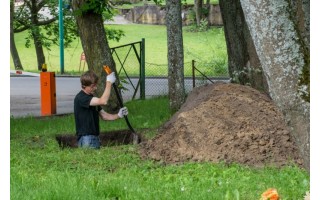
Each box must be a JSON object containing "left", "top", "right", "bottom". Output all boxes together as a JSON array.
[{"left": 240, "top": 0, "right": 310, "bottom": 170}]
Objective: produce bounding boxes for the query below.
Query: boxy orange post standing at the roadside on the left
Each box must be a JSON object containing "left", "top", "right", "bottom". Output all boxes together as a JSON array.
[{"left": 40, "top": 72, "right": 57, "bottom": 116}]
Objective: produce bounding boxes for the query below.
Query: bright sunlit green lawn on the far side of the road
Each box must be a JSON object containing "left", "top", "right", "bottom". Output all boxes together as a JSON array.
[{"left": 10, "top": 24, "right": 227, "bottom": 72}]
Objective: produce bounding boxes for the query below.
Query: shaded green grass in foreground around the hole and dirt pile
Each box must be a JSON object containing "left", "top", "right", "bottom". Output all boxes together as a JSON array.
[{"left": 10, "top": 97, "right": 310, "bottom": 200}]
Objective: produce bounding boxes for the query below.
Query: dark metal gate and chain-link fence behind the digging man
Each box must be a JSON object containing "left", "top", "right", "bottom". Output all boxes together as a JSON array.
[{"left": 111, "top": 39, "right": 229, "bottom": 101}]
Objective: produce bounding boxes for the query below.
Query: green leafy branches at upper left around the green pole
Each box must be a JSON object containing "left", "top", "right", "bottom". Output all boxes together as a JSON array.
[{"left": 13, "top": 0, "right": 78, "bottom": 50}]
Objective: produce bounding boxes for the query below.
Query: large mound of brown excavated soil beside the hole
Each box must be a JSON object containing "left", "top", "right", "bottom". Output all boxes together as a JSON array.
[{"left": 139, "top": 83, "right": 302, "bottom": 167}]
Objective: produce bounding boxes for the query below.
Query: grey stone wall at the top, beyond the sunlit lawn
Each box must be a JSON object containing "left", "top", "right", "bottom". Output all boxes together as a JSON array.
[{"left": 119, "top": 4, "right": 223, "bottom": 26}]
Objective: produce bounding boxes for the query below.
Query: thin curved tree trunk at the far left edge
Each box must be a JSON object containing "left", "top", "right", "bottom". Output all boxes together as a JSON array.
[{"left": 10, "top": 0, "right": 23, "bottom": 70}]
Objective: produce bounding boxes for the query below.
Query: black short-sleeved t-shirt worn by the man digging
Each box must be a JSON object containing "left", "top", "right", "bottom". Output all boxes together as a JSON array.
[{"left": 74, "top": 90, "right": 102, "bottom": 136}]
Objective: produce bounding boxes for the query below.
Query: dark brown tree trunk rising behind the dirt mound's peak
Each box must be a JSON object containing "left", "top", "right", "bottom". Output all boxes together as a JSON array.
[{"left": 219, "top": 0, "right": 268, "bottom": 93}]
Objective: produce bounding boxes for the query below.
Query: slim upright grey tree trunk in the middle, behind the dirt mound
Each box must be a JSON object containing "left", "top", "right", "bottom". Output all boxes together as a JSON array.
[{"left": 166, "top": 0, "right": 185, "bottom": 112}]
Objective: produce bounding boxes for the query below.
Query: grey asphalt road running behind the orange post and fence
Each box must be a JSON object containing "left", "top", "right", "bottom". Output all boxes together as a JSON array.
[{"left": 10, "top": 76, "right": 230, "bottom": 117}]
